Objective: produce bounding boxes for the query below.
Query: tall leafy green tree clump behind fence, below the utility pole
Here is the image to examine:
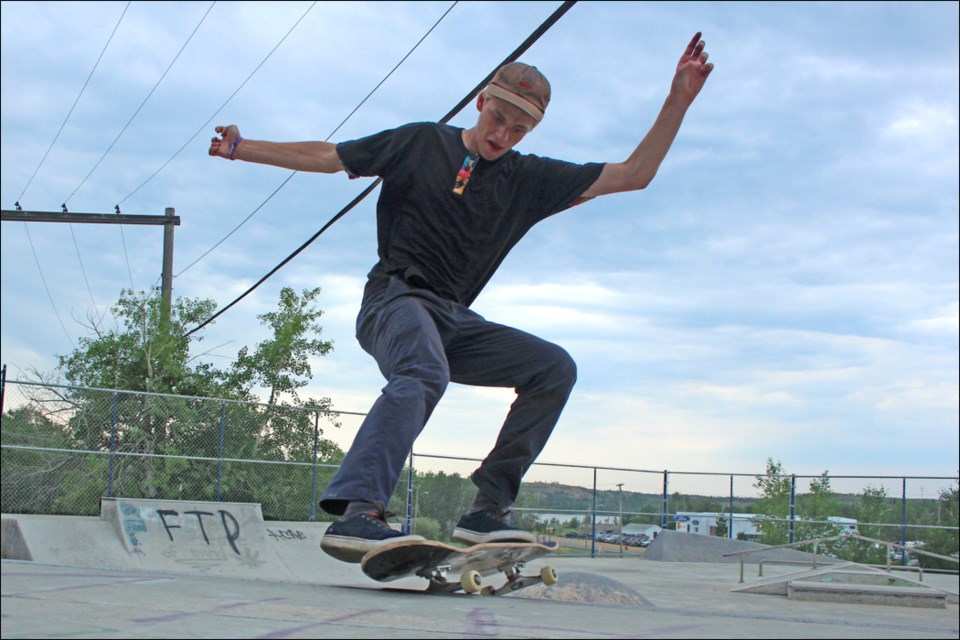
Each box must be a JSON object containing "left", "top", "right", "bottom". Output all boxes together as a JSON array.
[{"left": 3, "top": 288, "right": 343, "bottom": 519}]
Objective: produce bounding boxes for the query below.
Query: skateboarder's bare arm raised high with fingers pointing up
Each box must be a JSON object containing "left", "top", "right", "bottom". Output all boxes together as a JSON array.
[{"left": 581, "top": 32, "right": 713, "bottom": 198}]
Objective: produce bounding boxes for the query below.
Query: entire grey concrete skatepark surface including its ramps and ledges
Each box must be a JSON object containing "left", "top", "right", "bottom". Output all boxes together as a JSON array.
[{"left": 0, "top": 499, "right": 960, "bottom": 638}]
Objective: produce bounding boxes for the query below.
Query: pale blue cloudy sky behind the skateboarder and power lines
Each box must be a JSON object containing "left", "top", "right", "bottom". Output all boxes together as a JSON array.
[{"left": 0, "top": 1, "right": 960, "bottom": 484}]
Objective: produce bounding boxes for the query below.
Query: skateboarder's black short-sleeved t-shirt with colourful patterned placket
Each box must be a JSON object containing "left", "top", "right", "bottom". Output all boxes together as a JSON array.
[{"left": 337, "top": 123, "right": 603, "bottom": 306}]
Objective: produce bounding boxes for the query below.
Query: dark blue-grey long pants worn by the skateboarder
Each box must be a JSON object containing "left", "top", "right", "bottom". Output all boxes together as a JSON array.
[{"left": 320, "top": 277, "right": 577, "bottom": 515}]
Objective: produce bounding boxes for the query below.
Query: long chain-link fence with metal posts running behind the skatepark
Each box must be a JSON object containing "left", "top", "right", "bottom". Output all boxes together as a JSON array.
[{"left": 2, "top": 380, "right": 960, "bottom": 570}]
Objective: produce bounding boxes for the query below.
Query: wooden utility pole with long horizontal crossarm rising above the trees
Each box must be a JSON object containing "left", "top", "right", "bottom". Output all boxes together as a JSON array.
[{"left": 0, "top": 203, "right": 180, "bottom": 328}]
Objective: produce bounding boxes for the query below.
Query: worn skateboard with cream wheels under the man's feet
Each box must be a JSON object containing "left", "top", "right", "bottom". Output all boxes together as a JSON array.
[{"left": 360, "top": 540, "right": 559, "bottom": 596}]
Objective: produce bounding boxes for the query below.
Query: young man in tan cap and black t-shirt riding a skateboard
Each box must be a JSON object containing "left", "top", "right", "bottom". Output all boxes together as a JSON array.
[{"left": 209, "top": 33, "right": 713, "bottom": 562}]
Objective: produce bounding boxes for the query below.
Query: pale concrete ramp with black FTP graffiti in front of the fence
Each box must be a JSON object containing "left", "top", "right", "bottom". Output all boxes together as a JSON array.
[{"left": 2, "top": 498, "right": 338, "bottom": 581}]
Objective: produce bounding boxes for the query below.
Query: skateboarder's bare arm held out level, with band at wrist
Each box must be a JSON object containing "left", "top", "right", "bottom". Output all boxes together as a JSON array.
[{"left": 207, "top": 125, "right": 343, "bottom": 173}]
